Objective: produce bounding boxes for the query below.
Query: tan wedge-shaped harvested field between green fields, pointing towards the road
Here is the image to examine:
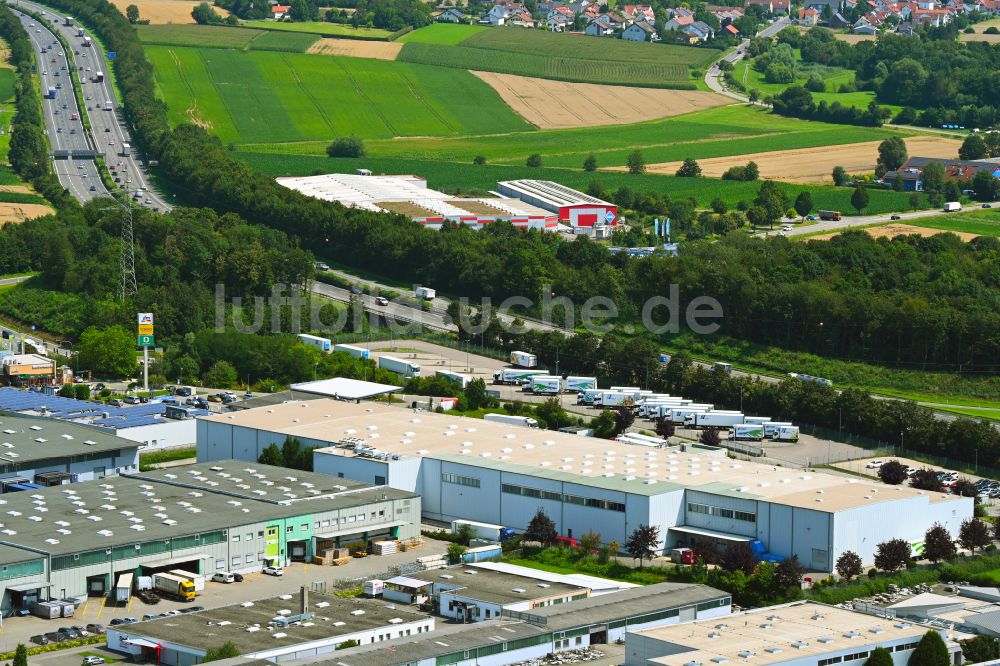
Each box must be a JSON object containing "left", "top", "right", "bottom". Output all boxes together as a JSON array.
[{"left": 472, "top": 72, "right": 732, "bottom": 129}]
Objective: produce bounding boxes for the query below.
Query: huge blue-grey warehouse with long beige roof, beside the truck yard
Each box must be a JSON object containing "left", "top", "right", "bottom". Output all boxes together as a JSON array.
[{"left": 198, "top": 400, "right": 973, "bottom": 571}]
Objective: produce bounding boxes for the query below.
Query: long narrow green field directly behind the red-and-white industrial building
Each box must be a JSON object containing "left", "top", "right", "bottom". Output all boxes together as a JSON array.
[{"left": 235, "top": 150, "right": 920, "bottom": 214}]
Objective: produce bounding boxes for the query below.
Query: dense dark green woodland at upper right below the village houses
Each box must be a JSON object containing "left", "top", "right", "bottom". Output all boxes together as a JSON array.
[{"left": 779, "top": 28, "right": 1000, "bottom": 128}]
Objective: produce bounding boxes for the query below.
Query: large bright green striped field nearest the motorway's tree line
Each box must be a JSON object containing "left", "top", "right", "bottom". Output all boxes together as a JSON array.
[{"left": 146, "top": 46, "right": 531, "bottom": 143}]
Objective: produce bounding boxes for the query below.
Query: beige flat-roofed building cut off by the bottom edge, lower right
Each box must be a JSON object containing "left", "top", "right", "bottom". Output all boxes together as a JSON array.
[{"left": 625, "top": 602, "right": 962, "bottom": 666}]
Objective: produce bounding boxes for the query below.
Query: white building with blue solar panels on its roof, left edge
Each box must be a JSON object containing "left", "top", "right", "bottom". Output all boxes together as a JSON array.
[{"left": 0, "top": 388, "right": 208, "bottom": 450}]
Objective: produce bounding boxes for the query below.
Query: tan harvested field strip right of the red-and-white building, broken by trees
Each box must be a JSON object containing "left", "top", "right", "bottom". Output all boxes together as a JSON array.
[{"left": 636, "top": 136, "right": 962, "bottom": 183}]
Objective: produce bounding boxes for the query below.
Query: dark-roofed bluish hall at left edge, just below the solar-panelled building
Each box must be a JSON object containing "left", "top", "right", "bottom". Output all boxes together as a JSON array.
[{"left": 0, "top": 414, "right": 139, "bottom": 482}]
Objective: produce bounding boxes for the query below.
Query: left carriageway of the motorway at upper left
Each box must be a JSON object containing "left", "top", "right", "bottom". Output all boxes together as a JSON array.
[{"left": 12, "top": 10, "right": 108, "bottom": 202}]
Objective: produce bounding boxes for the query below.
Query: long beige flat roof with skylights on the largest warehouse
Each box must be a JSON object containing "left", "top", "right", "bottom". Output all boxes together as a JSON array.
[{"left": 204, "top": 399, "right": 971, "bottom": 512}]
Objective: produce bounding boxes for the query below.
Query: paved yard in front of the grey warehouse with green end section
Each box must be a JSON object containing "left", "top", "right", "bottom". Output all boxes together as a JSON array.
[{"left": 0, "top": 539, "right": 448, "bottom": 652}]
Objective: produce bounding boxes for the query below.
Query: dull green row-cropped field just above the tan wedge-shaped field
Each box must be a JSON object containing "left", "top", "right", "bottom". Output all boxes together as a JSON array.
[{"left": 399, "top": 28, "right": 719, "bottom": 89}]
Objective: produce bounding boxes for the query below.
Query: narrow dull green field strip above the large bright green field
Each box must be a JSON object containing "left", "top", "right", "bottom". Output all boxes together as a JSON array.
[{"left": 136, "top": 25, "right": 320, "bottom": 53}]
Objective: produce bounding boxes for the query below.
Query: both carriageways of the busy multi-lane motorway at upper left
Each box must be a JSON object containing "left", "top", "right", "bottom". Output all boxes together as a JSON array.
[{"left": 14, "top": 0, "right": 171, "bottom": 212}]
